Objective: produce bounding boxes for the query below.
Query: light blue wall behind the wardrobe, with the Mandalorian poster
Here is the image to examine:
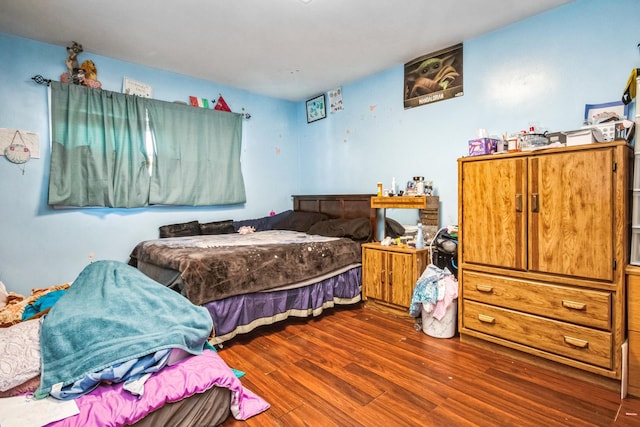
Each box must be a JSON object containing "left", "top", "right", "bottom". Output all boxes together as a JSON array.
[{"left": 298, "top": 0, "right": 640, "bottom": 225}]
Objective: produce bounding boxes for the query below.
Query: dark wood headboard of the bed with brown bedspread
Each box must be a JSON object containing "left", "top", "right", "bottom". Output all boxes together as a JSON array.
[{"left": 292, "top": 194, "right": 376, "bottom": 230}]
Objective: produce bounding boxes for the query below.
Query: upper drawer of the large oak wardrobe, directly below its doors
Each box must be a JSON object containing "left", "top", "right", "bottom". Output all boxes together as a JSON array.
[{"left": 462, "top": 271, "right": 611, "bottom": 330}]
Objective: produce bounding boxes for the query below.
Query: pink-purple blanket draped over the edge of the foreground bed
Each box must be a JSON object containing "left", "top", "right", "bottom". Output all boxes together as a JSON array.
[{"left": 47, "top": 350, "right": 269, "bottom": 427}]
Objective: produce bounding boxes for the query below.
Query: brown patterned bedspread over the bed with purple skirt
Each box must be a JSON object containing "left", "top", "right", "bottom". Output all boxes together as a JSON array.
[{"left": 131, "top": 230, "right": 362, "bottom": 305}]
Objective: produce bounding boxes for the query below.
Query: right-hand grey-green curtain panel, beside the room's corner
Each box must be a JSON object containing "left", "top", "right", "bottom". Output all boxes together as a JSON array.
[{"left": 148, "top": 101, "right": 246, "bottom": 206}]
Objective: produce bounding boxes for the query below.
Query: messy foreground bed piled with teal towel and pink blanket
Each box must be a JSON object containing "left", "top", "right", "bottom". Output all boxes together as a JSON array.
[{"left": 0, "top": 261, "right": 269, "bottom": 427}]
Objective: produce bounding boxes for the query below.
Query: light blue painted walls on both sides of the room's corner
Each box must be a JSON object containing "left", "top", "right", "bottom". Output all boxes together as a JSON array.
[{"left": 0, "top": 0, "right": 640, "bottom": 293}]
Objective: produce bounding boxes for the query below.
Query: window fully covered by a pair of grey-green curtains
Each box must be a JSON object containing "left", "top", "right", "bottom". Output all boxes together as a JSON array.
[{"left": 49, "top": 82, "right": 246, "bottom": 208}]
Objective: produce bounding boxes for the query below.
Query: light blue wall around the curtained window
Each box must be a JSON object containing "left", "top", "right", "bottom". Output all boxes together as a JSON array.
[{"left": 0, "top": 34, "right": 299, "bottom": 294}]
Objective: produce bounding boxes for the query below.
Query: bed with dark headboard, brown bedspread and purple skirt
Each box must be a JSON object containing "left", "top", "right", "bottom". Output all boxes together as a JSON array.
[{"left": 131, "top": 194, "right": 376, "bottom": 345}]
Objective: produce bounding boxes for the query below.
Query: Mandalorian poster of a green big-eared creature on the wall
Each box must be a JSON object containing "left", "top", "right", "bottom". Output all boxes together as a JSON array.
[{"left": 404, "top": 44, "right": 464, "bottom": 109}]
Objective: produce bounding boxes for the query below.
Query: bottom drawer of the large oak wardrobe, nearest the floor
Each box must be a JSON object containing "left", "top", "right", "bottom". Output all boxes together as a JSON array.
[{"left": 462, "top": 300, "right": 612, "bottom": 369}]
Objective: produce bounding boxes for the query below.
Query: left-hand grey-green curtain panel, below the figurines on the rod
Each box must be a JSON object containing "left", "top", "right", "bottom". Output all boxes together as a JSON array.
[{"left": 49, "top": 82, "right": 150, "bottom": 208}]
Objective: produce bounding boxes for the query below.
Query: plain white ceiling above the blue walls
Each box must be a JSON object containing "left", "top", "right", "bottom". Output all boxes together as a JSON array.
[{"left": 0, "top": 0, "right": 572, "bottom": 101}]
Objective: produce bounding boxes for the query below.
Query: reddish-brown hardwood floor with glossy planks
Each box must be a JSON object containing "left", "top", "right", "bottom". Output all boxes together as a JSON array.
[{"left": 220, "top": 306, "right": 640, "bottom": 427}]
